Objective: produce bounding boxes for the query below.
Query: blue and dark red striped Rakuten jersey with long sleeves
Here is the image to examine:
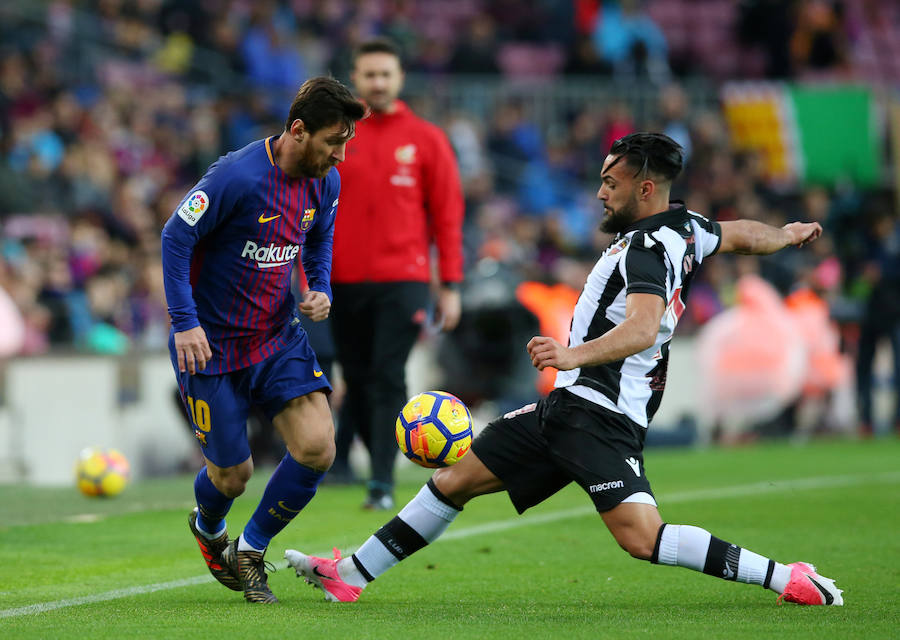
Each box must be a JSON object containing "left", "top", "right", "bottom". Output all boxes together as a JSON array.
[{"left": 162, "top": 137, "right": 341, "bottom": 374}]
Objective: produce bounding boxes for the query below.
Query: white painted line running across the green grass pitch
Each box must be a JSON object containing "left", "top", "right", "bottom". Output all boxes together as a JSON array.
[{"left": 0, "top": 471, "right": 900, "bottom": 618}]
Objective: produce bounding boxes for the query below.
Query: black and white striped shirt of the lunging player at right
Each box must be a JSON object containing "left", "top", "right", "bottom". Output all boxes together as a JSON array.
[{"left": 556, "top": 202, "right": 722, "bottom": 427}]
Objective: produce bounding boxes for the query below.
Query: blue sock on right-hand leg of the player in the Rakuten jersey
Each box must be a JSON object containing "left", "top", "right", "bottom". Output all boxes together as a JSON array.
[{"left": 243, "top": 453, "right": 325, "bottom": 550}]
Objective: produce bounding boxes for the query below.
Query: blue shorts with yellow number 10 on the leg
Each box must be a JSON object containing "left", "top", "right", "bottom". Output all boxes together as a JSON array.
[{"left": 172, "top": 332, "right": 331, "bottom": 467}]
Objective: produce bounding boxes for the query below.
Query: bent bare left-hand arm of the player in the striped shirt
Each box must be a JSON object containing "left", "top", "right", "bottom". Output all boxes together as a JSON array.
[{"left": 526, "top": 293, "right": 666, "bottom": 371}]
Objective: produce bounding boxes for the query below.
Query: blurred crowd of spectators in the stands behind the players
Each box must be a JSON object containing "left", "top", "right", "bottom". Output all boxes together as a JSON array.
[{"left": 0, "top": 0, "right": 900, "bottom": 436}]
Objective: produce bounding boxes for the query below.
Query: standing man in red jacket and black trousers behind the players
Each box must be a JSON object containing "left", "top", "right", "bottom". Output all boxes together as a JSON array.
[{"left": 331, "top": 38, "right": 463, "bottom": 509}]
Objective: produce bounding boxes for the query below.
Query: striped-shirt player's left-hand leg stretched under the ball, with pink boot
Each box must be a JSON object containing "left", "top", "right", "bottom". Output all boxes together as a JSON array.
[{"left": 285, "top": 404, "right": 570, "bottom": 602}]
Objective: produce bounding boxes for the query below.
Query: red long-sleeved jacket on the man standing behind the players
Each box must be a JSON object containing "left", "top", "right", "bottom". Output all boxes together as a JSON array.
[{"left": 331, "top": 101, "right": 463, "bottom": 283}]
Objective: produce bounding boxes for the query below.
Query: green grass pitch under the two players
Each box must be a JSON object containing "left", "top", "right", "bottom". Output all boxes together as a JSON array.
[{"left": 0, "top": 439, "right": 900, "bottom": 640}]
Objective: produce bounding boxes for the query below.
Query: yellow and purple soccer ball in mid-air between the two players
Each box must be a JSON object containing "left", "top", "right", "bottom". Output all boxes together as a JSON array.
[{"left": 396, "top": 391, "right": 472, "bottom": 468}]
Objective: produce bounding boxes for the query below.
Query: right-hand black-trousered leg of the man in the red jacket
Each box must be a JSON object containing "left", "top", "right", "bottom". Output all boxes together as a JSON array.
[{"left": 363, "top": 282, "right": 428, "bottom": 510}]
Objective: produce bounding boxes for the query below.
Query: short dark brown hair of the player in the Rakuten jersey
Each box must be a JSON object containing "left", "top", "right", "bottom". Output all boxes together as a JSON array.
[{"left": 285, "top": 76, "right": 366, "bottom": 137}]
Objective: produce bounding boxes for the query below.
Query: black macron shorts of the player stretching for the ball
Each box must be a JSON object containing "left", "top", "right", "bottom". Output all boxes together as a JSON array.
[{"left": 472, "top": 389, "right": 653, "bottom": 513}]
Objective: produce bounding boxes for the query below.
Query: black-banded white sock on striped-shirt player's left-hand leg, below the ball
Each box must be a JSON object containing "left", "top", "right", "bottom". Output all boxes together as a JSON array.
[{"left": 350, "top": 480, "right": 461, "bottom": 586}]
